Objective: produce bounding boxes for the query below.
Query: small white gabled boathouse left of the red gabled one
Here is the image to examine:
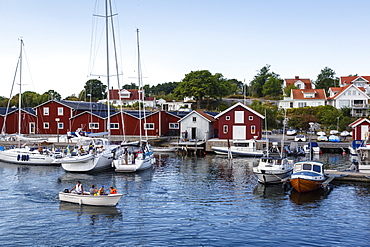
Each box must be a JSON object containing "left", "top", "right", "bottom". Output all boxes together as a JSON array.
[{"left": 179, "top": 110, "right": 217, "bottom": 141}]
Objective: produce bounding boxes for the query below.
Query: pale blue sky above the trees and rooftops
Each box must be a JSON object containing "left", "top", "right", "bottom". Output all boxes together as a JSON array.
[{"left": 0, "top": 0, "right": 370, "bottom": 98}]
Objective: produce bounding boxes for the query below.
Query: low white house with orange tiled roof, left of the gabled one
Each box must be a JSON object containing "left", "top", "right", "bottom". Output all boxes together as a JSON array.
[{"left": 279, "top": 89, "right": 326, "bottom": 109}]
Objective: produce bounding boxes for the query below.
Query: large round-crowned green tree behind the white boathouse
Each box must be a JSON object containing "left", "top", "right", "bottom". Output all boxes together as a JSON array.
[{"left": 174, "top": 70, "right": 230, "bottom": 109}]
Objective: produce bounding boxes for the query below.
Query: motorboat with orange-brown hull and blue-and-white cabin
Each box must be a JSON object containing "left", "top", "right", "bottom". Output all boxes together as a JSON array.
[{"left": 290, "top": 160, "right": 327, "bottom": 193}]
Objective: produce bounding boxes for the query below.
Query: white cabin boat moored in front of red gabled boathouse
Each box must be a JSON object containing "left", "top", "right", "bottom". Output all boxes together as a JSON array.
[{"left": 212, "top": 139, "right": 264, "bottom": 157}]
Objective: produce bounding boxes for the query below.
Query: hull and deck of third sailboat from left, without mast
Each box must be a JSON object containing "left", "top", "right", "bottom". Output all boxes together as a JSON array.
[{"left": 112, "top": 141, "right": 155, "bottom": 172}]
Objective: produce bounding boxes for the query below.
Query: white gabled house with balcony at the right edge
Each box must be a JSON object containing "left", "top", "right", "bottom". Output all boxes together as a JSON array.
[{"left": 327, "top": 84, "right": 370, "bottom": 117}]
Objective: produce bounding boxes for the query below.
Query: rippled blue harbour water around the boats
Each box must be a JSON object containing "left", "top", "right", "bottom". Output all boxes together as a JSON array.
[{"left": 0, "top": 154, "right": 370, "bottom": 246}]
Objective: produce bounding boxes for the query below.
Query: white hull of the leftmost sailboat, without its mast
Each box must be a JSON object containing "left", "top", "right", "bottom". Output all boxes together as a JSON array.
[{"left": 0, "top": 148, "right": 60, "bottom": 165}]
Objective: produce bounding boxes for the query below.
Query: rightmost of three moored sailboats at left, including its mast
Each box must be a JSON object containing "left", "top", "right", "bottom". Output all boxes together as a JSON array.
[{"left": 113, "top": 29, "right": 155, "bottom": 172}]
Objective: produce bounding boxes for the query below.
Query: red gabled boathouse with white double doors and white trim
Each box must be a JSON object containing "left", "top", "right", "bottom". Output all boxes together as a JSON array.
[{"left": 215, "top": 103, "right": 265, "bottom": 140}]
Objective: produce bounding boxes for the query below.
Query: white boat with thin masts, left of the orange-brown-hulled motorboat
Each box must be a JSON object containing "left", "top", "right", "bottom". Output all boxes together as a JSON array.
[{"left": 253, "top": 112, "right": 293, "bottom": 184}]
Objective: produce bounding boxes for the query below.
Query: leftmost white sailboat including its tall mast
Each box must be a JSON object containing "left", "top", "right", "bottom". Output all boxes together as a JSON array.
[{"left": 0, "top": 39, "right": 59, "bottom": 165}]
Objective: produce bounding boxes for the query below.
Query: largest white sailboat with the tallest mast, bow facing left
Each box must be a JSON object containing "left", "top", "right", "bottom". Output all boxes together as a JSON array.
[{"left": 60, "top": 0, "right": 117, "bottom": 172}]
